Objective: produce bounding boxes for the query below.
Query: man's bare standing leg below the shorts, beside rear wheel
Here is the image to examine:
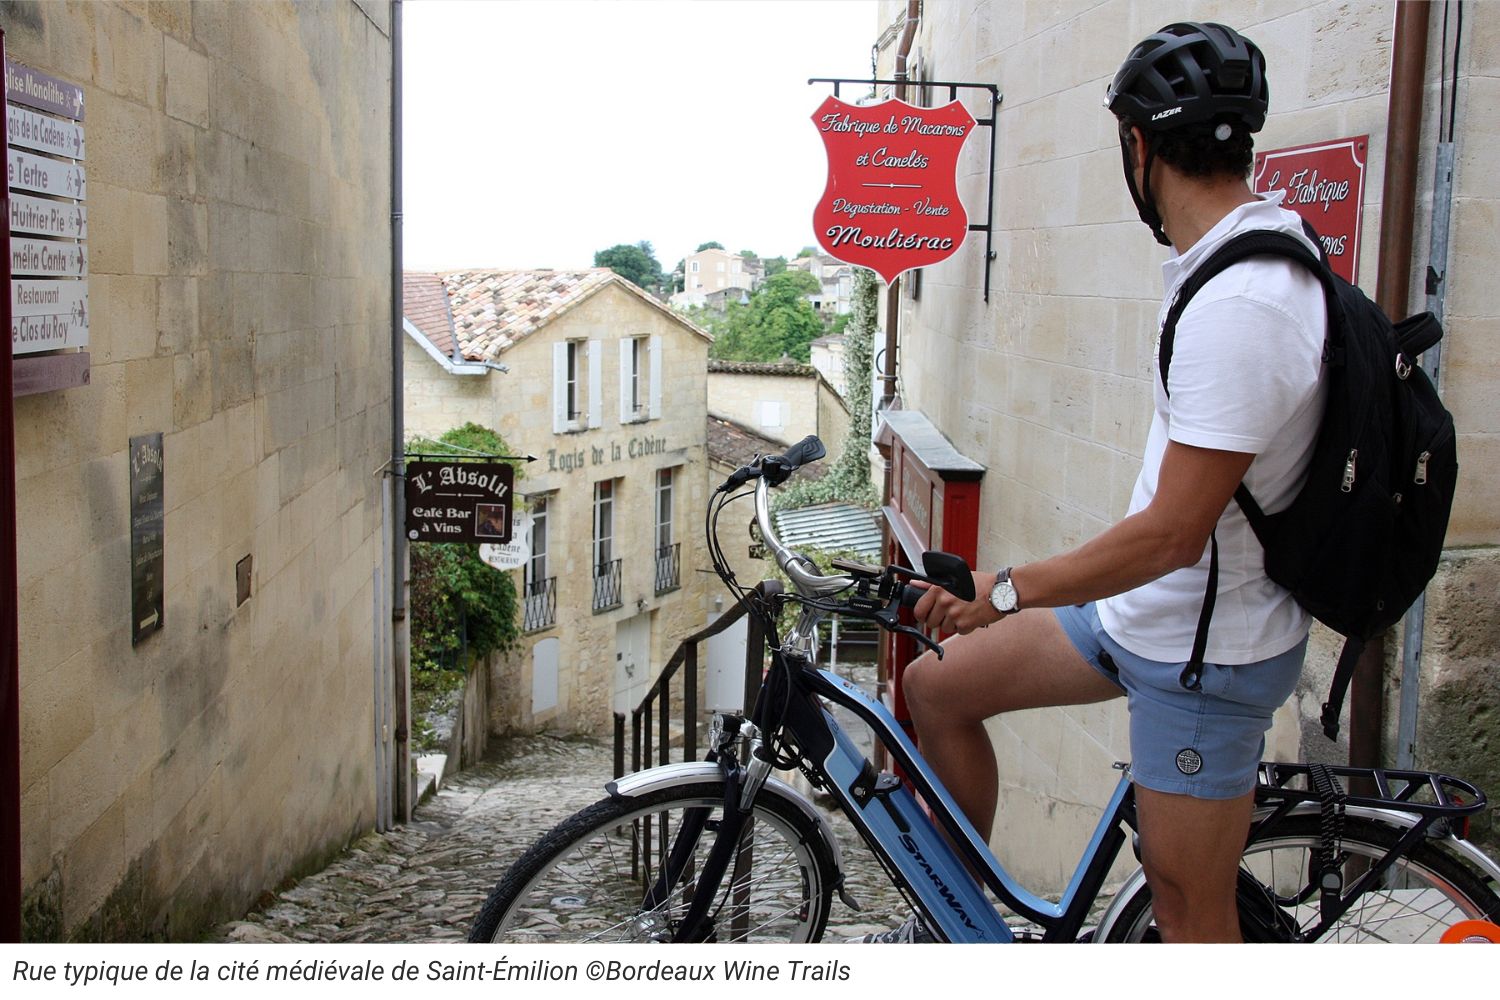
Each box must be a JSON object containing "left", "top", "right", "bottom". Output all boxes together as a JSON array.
[{"left": 1136, "top": 784, "right": 1256, "bottom": 942}]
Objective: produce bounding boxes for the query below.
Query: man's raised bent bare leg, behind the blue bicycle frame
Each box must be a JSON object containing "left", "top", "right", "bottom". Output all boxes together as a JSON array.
[{"left": 902, "top": 607, "right": 1122, "bottom": 856}]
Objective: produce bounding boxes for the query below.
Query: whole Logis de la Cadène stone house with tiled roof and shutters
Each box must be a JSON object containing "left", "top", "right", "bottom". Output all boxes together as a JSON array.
[{"left": 404, "top": 268, "right": 713, "bottom": 733}]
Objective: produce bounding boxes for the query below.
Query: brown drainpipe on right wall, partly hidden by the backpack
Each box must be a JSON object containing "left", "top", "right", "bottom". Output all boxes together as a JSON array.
[{"left": 1349, "top": 0, "right": 1431, "bottom": 768}]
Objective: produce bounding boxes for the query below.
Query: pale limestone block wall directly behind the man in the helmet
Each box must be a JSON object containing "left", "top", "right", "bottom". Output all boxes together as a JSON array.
[{"left": 875, "top": 0, "right": 1500, "bottom": 886}]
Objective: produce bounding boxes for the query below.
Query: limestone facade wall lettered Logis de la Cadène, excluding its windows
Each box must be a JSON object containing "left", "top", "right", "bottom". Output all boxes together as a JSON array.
[{"left": 474, "top": 285, "right": 717, "bottom": 736}]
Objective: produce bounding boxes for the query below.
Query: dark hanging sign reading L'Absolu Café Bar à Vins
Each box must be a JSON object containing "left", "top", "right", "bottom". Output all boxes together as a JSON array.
[{"left": 407, "top": 462, "right": 516, "bottom": 544}]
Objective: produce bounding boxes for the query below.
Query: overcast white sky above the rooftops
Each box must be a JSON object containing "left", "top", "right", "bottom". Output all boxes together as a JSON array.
[{"left": 402, "top": 0, "right": 881, "bottom": 270}]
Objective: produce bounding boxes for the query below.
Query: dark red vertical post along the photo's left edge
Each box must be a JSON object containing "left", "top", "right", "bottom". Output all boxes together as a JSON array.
[{"left": 0, "top": 23, "right": 21, "bottom": 945}]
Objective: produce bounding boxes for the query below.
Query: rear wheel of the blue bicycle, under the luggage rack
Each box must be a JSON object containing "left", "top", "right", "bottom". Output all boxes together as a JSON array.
[{"left": 1104, "top": 816, "right": 1500, "bottom": 943}]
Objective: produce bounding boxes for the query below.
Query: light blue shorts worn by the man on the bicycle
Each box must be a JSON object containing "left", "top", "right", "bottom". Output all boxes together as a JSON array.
[{"left": 1056, "top": 603, "right": 1307, "bottom": 799}]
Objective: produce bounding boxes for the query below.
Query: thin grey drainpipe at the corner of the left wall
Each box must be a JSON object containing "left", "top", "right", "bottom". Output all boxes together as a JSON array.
[{"left": 390, "top": 0, "right": 413, "bottom": 823}]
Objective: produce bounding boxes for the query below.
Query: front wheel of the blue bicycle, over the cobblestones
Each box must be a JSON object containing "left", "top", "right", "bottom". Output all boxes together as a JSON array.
[{"left": 470, "top": 781, "right": 836, "bottom": 943}]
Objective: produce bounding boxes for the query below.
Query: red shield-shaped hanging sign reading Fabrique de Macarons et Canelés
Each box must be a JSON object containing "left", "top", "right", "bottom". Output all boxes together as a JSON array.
[{"left": 813, "top": 97, "right": 975, "bottom": 280}]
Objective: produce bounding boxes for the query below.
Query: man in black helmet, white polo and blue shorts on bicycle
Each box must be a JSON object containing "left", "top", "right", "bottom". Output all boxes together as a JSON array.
[{"left": 903, "top": 24, "right": 1326, "bottom": 942}]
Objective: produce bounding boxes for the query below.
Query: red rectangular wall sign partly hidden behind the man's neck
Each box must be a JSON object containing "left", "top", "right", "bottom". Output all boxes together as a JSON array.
[{"left": 1254, "top": 135, "right": 1370, "bottom": 285}]
